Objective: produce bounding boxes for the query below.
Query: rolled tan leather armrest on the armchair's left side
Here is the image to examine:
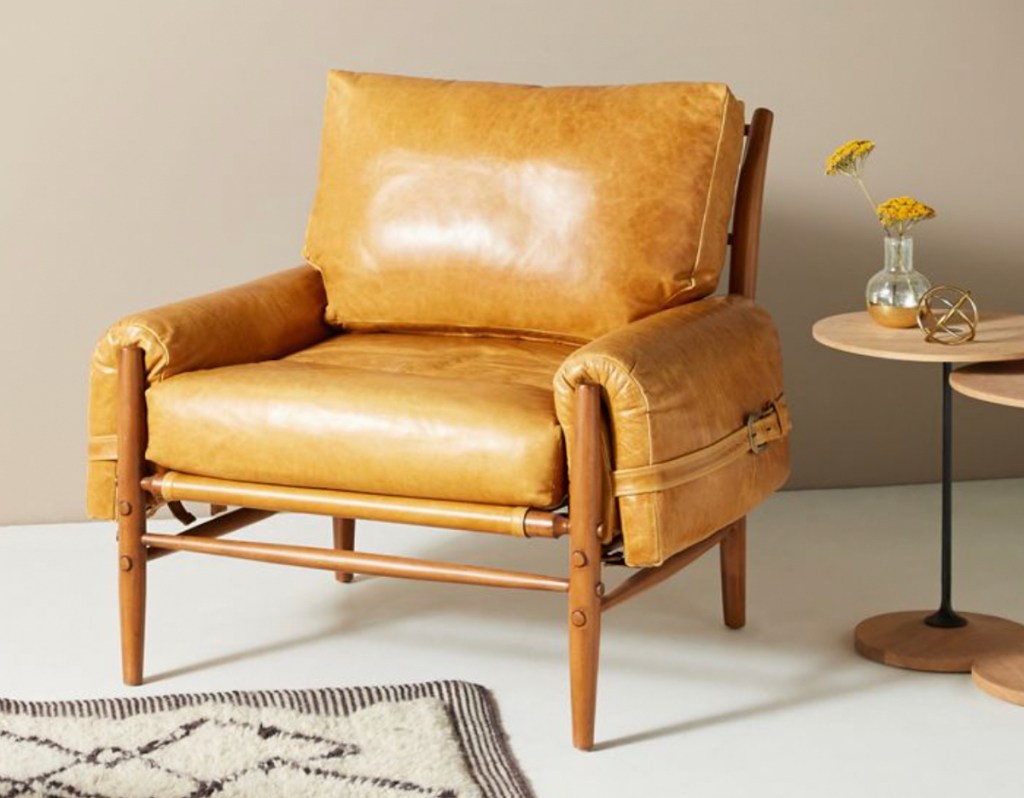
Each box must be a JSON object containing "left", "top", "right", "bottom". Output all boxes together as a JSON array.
[{"left": 86, "top": 265, "right": 330, "bottom": 518}]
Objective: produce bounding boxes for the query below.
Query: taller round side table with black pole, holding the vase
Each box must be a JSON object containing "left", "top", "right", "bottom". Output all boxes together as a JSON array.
[{"left": 812, "top": 311, "right": 1024, "bottom": 673}]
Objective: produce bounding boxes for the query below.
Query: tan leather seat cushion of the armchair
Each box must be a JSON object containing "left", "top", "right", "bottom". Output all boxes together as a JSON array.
[{"left": 146, "top": 333, "right": 572, "bottom": 507}]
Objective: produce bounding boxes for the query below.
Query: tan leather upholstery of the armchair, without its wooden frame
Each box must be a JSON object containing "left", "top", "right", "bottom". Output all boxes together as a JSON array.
[{"left": 88, "top": 73, "right": 788, "bottom": 566}]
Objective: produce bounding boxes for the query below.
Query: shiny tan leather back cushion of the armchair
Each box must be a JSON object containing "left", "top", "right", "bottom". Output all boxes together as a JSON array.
[{"left": 304, "top": 72, "right": 743, "bottom": 341}]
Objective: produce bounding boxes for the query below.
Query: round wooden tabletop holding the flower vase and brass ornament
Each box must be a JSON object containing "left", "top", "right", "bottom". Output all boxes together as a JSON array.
[{"left": 812, "top": 310, "right": 1024, "bottom": 363}]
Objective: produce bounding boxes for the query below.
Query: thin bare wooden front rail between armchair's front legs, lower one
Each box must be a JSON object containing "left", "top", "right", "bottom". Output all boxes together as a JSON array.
[{"left": 142, "top": 535, "right": 568, "bottom": 593}]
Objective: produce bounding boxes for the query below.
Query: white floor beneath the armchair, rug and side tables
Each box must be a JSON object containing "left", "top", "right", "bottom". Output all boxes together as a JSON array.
[{"left": 0, "top": 480, "right": 1024, "bottom": 798}]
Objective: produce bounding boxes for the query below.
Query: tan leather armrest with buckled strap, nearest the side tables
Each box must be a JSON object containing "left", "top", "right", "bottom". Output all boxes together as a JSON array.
[{"left": 555, "top": 296, "right": 788, "bottom": 565}]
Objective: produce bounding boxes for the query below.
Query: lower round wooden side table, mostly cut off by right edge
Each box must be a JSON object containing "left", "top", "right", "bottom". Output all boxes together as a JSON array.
[{"left": 949, "top": 361, "right": 1024, "bottom": 705}]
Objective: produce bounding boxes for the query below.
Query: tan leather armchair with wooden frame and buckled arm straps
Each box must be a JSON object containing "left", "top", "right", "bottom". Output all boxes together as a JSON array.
[{"left": 88, "top": 72, "right": 790, "bottom": 749}]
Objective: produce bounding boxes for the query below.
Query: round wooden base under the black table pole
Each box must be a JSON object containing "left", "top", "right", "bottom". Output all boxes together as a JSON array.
[{"left": 853, "top": 610, "right": 1024, "bottom": 683}]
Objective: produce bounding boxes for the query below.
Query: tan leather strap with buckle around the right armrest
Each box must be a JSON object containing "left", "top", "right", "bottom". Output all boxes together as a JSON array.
[{"left": 612, "top": 394, "right": 792, "bottom": 496}]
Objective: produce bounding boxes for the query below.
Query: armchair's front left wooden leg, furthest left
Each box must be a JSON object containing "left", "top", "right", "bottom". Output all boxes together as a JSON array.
[{"left": 116, "top": 346, "right": 146, "bottom": 684}]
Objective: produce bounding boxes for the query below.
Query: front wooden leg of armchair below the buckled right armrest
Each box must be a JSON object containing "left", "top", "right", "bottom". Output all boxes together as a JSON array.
[{"left": 568, "top": 384, "right": 604, "bottom": 751}]
